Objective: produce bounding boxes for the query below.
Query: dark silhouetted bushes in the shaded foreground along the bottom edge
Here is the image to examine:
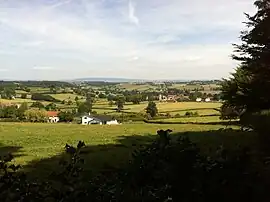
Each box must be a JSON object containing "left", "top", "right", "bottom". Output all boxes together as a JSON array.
[{"left": 0, "top": 130, "right": 269, "bottom": 202}]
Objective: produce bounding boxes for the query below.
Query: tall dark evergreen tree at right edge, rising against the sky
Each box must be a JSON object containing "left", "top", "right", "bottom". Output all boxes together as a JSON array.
[{"left": 222, "top": 0, "right": 270, "bottom": 112}]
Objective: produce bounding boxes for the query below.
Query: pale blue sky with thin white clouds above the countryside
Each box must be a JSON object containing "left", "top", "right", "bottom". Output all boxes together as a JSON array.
[{"left": 0, "top": 0, "right": 255, "bottom": 80}]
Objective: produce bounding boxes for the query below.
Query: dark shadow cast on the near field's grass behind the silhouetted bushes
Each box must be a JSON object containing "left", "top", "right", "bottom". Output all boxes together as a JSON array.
[{"left": 21, "top": 130, "right": 256, "bottom": 179}]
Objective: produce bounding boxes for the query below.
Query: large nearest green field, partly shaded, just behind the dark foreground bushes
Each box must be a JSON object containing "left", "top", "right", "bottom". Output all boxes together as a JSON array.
[{"left": 0, "top": 120, "right": 248, "bottom": 178}]
